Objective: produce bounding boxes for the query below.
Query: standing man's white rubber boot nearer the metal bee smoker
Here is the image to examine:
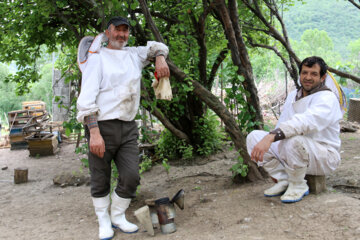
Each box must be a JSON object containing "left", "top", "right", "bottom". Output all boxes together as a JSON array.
[{"left": 111, "top": 191, "right": 139, "bottom": 233}]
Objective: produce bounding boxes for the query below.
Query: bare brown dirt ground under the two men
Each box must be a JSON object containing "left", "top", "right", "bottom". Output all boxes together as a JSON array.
[{"left": 0, "top": 130, "right": 360, "bottom": 240}]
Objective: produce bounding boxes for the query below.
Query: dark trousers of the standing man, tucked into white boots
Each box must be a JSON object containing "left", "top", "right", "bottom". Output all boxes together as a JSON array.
[{"left": 85, "top": 120, "right": 140, "bottom": 198}]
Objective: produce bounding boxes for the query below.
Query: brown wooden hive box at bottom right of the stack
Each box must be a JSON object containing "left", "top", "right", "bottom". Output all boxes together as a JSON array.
[{"left": 27, "top": 134, "right": 58, "bottom": 157}]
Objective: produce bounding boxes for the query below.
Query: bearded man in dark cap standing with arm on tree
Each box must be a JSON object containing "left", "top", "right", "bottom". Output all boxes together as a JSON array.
[{"left": 77, "top": 17, "right": 170, "bottom": 239}]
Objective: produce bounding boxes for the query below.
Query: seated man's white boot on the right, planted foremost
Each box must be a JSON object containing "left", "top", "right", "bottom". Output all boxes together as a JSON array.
[{"left": 280, "top": 167, "right": 309, "bottom": 203}]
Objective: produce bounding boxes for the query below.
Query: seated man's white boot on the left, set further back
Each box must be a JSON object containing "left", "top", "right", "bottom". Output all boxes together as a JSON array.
[{"left": 263, "top": 158, "right": 289, "bottom": 197}]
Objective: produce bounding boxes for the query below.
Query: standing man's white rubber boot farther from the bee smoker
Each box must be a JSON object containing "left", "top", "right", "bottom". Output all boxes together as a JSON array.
[{"left": 92, "top": 195, "right": 114, "bottom": 240}]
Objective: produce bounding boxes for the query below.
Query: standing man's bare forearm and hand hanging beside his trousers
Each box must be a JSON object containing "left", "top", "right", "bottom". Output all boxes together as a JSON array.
[{"left": 84, "top": 114, "right": 105, "bottom": 158}]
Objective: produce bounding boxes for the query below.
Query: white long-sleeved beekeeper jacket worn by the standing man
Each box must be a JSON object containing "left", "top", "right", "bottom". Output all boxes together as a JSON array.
[{"left": 77, "top": 41, "right": 168, "bottom": 122}]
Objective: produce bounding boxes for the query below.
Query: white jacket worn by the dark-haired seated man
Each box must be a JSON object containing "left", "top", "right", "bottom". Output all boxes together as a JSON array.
[{"left": 276, "top": 90, "right": 342, "bottom": 153}]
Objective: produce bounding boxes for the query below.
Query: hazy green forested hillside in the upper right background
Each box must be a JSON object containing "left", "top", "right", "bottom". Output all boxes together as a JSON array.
[{"left": 283, "top": 0, "right": 360, "bottom": 55}]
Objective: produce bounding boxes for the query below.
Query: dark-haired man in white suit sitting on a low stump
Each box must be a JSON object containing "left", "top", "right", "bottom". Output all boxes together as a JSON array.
[{"left": 246, "top": 56, "right": 342, "bottom": 203}]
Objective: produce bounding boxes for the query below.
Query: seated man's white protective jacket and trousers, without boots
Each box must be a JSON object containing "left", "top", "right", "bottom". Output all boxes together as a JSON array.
[{"left": 247, "top": 90, "right": 342, "bottom": 180}]
